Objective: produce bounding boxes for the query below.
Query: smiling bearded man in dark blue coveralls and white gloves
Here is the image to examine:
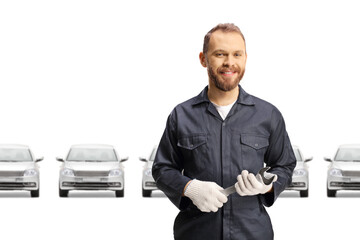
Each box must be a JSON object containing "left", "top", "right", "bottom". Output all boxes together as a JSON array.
[{"left": 153, "top": 24, "right": 296, "bottom": 240}]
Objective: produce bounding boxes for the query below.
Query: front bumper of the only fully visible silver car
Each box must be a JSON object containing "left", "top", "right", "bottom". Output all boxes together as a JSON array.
[{"left": 59, "top": 176, "right": 124, "bottom": 191}]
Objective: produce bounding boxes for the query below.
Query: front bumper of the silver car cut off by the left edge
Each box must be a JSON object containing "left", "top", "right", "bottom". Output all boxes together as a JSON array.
[{"left": 0, "top": 176, "right": 39, "bottom": 191}]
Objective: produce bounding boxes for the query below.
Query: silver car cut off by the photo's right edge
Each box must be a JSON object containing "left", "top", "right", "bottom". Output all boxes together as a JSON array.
[{"left": 324, "top": 144, "right": 360, "bottom": 197}]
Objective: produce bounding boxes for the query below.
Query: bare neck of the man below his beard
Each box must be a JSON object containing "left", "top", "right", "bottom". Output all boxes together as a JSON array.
[{"left": 208, "top": 84, "right": 239, "bottom": 106}]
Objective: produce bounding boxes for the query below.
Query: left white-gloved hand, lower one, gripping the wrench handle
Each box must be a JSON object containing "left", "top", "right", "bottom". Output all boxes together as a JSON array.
[{"left": 184, "top": 179, "right": 227, "bottom": 212}]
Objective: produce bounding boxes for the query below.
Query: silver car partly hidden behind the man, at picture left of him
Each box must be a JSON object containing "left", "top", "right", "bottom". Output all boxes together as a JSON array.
[{"left": 139, "top": 146, "right": 158, "bottom": 197}]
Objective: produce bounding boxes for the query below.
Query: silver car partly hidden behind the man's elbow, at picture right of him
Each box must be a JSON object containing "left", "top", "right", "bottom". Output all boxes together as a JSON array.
[{"left": 286, "top": 145, "right": 313, "bottom": 197}]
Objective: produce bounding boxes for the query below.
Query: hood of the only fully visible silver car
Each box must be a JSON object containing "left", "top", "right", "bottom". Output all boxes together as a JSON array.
[{"left": 64, "top": 162, "right": 122, "bottom": 171}]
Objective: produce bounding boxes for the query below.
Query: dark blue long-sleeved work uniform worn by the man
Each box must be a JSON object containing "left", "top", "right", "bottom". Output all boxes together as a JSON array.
[{"left": 152, "top": 86, "right": 296, "bottom": 240}]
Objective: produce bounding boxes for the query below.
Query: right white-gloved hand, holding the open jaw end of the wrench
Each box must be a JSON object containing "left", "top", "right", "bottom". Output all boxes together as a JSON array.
[{"left": 235, "top": 170, "right": 277, "bottom": 196}]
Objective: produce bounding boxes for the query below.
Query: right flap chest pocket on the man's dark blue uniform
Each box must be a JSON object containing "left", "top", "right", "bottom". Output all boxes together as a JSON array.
[{"left": 240, "top": 134, "right": 269, "bottom": 173}]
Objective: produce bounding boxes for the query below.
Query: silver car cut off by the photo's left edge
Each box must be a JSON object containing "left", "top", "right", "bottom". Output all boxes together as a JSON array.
[{"left": 0, "top": 144, "right": 44, "bottom": 197}]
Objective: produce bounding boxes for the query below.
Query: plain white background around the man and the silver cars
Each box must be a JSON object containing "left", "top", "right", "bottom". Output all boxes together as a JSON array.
[{"left": 0, "top": 0, "right": 360, "bottom": 239}]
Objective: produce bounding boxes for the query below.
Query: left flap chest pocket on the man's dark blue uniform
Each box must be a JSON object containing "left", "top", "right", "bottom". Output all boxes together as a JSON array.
[{"left": 177, "top": 134, "right": 208, "bottom": 178}]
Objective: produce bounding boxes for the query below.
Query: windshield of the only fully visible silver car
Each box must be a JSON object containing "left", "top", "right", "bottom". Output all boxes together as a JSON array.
[{"left": 67, "top": 148, "right": 117, "bottom": 162}]
